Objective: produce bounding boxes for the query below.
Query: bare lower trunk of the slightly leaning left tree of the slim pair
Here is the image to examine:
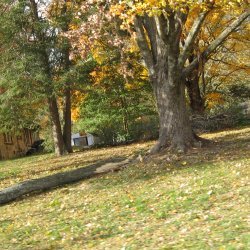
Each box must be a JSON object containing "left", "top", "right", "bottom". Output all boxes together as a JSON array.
[{"left": 48, "top": 96, "right": 65, "bottom": 156}]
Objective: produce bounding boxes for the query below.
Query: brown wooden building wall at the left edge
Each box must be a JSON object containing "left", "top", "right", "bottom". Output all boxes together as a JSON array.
[{"left": 0, "top": 129, "right": 39, "bottom": 160}]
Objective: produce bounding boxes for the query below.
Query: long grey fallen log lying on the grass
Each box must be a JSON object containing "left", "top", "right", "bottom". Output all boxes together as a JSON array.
[{"left": 0, "top": 158, "right": 132, "bottom": 205}]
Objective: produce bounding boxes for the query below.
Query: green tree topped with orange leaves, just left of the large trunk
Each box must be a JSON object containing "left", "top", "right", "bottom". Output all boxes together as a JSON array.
[{"left": 76, "top": 47, "right": 157, "bottom": 145}]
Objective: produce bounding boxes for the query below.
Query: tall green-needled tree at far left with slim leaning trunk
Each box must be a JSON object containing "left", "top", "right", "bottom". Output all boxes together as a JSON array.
[{"left": 0, "top": 0, "right": 74, "bottom": 155}]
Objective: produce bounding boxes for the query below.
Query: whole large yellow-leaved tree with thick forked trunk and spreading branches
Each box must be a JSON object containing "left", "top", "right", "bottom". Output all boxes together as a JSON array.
[{"left": 88, "top": 0, "right": 250, "bottom": 153}]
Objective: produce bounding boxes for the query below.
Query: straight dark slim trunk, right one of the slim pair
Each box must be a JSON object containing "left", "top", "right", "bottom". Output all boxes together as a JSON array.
[{"left": 63, "top": 87, "right": 73, "bottom": 153}]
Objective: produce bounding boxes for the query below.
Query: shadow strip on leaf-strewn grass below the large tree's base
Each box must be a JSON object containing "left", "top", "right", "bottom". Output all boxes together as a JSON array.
[{"left": 86, "top": 135, "right": 250, "bottom": 189}]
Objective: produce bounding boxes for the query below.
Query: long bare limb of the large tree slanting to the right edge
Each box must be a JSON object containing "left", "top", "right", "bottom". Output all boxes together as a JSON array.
[{"left": 183, "top": 9, "right": 250, "bottom": 76}]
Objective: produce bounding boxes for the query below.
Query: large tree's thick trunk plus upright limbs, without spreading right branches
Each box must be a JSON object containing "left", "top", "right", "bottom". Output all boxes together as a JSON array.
[{"left": 135, "top": 15, "right": 199, "bottom": 153}]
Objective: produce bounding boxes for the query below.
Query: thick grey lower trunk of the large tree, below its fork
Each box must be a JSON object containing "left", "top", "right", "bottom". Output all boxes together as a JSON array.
[{"left": 151, "top": 75, "right": 196, "bottom": 153}]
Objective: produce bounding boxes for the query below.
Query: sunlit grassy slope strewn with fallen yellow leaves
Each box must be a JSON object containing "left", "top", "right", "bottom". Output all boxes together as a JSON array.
[{"left": 0, "top": 128, "right": 250, "bottom": 250}]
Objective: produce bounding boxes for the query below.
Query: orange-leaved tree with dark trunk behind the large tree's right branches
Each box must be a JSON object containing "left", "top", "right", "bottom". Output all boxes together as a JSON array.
[{"left": 186, "top": 11, "right": 249, "bottom": 114}]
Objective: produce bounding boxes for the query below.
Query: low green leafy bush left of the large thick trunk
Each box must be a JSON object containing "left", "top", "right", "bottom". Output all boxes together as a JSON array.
[{"left": 74, "top": 86, "right": 158, "bottom": 145}]
